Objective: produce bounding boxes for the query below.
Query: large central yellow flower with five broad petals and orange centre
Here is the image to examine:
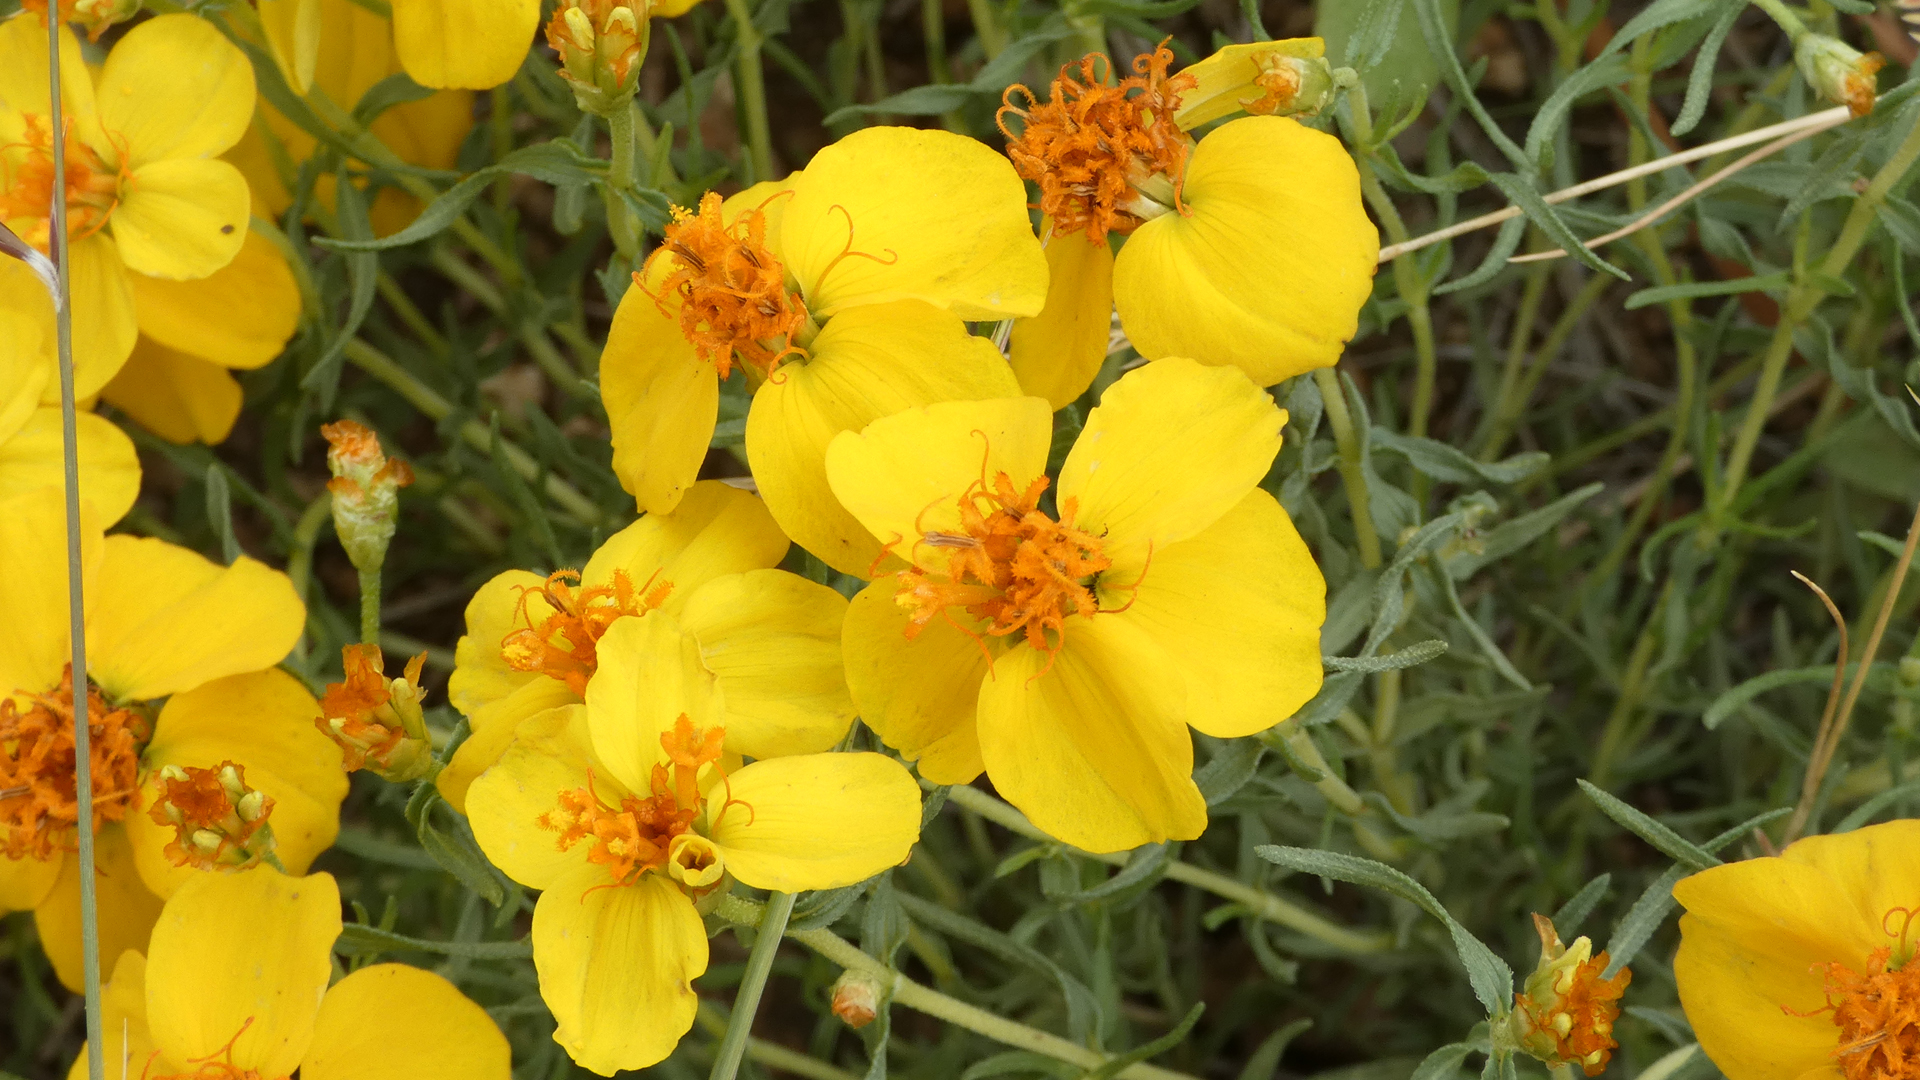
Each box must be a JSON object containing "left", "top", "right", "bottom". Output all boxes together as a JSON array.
[{"left": 828, "top": 357, "right": 1327, "bottom": 851}]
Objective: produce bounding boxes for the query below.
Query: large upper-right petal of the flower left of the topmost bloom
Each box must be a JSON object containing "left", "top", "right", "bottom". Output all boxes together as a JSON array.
[{"left": 780, "top": 127, "right": 1046, "bottom": 319}]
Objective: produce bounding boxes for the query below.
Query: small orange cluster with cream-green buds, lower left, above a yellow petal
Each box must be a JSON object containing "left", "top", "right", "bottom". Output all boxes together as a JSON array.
[{"left": 146, "top": 761, "right": 273, "bottom": 871}]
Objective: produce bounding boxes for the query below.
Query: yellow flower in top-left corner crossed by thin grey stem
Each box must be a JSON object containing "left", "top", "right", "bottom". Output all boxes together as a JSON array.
[{"left": 0, "top": 15, "right": 253, "bottom": 402}]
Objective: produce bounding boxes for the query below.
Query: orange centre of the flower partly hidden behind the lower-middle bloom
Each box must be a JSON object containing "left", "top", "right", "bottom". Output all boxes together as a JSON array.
[{"left": 503, "top": 571, "right": 674, "bottom": 691}]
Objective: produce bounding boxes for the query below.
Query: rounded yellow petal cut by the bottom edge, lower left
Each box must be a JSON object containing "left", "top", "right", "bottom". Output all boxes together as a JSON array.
[{"left": 300, "top": 965, "right": 513, "bottom": 1080}]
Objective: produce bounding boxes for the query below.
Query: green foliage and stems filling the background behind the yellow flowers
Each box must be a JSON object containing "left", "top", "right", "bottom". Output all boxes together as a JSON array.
[{"left": 0, "top": 0, "right": 1920, "bottom": 1080}]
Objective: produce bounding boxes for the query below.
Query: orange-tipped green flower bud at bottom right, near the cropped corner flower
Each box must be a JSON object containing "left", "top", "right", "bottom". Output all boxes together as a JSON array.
[{"left": 1507, "top": 915, "right": 1634, "bottom": 1076}]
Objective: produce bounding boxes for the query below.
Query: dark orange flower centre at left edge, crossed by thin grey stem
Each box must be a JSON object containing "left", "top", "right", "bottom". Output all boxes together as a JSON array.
[{"left": 0, "top": 667, "right": 152, "bottom": 859}]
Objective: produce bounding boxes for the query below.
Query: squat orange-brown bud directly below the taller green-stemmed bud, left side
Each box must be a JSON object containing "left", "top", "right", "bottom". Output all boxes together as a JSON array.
[{"left": 313, "top": 646, "right": 434, "bottom": 784}]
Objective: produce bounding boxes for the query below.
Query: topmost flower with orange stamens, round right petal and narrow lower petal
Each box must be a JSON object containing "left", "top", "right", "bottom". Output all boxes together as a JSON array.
[{"left": 1000, "top": 39, "right": 1380, "bottom": 407}]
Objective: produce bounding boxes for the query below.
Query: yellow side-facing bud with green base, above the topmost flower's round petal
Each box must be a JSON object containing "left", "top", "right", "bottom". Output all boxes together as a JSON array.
[{"left": 1173, "top": 38, "right": 1356, "bottom": 131}]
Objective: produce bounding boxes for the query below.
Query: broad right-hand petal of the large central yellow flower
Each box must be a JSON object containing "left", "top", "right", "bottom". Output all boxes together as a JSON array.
[{"left": 1100, "top": 488, "right": 1327, "bottom": 738}]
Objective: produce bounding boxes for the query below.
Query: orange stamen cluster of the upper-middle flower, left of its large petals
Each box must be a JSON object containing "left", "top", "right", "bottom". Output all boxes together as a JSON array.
[{"left": 634, "top": 192, "right": 806, "bottom": 379}]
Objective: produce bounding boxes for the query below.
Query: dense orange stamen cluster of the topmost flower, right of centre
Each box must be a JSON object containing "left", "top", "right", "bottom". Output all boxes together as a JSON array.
[{"left": 995, "top": 44, "right": 1194, "bottom": 240}]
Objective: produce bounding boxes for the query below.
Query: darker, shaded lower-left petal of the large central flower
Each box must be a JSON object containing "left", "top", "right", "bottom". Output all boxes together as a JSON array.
[{"left": 841, "top": 577, "right": 1006, "bottom": 784}]
